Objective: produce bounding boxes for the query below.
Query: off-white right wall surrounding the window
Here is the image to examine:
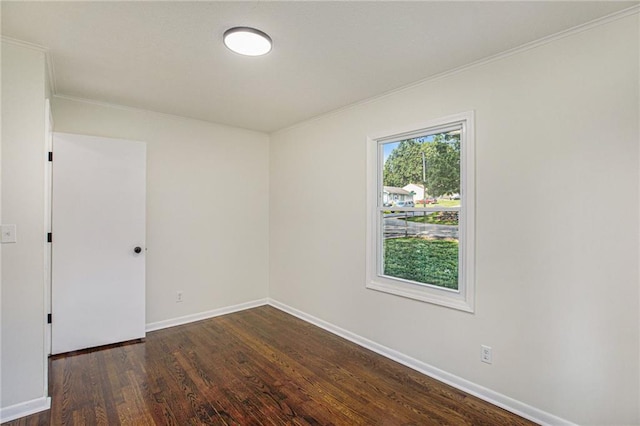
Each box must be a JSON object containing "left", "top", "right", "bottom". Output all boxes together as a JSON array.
[{"left": 270, "top": 15, "right": 640, "bottom": 424}]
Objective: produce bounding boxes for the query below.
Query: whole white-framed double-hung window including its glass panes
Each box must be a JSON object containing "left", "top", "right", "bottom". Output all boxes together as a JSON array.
[{"left": 367, "top": 112, "right": 475, "bottom": 312}]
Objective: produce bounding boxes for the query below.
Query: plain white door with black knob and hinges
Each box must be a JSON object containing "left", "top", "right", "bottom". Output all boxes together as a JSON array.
[{"left": 51, "top": 133, "right": 146, "bottom": 354}]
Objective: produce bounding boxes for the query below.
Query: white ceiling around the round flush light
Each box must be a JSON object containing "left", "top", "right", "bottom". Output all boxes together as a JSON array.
[{"left": 1, "top": 0, "right": 638, "bottom": 132}]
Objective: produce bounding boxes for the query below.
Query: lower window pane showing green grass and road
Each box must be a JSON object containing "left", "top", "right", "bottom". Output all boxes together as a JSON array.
[{"left": 380, "top": 211, "right": 459, "bottom": 290}]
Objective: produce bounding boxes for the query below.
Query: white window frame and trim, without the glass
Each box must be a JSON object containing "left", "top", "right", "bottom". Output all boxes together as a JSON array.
[{"left": 366, "top": 111, "right": 475, "bottom": 312}]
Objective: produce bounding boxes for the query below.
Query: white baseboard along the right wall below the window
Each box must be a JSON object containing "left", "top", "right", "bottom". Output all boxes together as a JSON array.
[{"left": 268, "top": 299, "right": 575, "bottom": 426}]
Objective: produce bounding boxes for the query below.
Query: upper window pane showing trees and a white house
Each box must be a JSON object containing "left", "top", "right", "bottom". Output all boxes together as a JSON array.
[{"left": 381, "top": 129, "right": 460, "bottom": 207}]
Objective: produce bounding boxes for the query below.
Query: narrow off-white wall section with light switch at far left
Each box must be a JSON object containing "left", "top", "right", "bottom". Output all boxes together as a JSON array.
[{"left": 0, "top": 41, "right": 47, "bottom": 410}]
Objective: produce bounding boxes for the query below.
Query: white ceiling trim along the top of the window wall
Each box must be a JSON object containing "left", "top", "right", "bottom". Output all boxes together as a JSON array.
[{"left": 270, "top": 3, "right": 640, "bottom": 134}]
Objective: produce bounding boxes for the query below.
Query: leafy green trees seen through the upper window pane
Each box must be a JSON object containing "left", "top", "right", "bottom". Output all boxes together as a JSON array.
[{"left": 383, "top": 133, "right": 460, "bottom": 197}]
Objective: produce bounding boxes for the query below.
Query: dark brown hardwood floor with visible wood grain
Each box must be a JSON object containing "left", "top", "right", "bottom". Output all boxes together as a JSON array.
[{"left": 2, "top": 306, "right": 532, "bottom": 426}]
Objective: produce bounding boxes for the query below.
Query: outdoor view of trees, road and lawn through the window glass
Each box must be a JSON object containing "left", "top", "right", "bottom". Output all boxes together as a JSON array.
[{"left": 380, "top": 126, "right": 461, "bottom": 290}]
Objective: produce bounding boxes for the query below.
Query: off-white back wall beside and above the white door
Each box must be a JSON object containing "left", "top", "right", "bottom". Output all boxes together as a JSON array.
[{"left": 52, "top": 98, "right": 269, "bottom": 324}]
